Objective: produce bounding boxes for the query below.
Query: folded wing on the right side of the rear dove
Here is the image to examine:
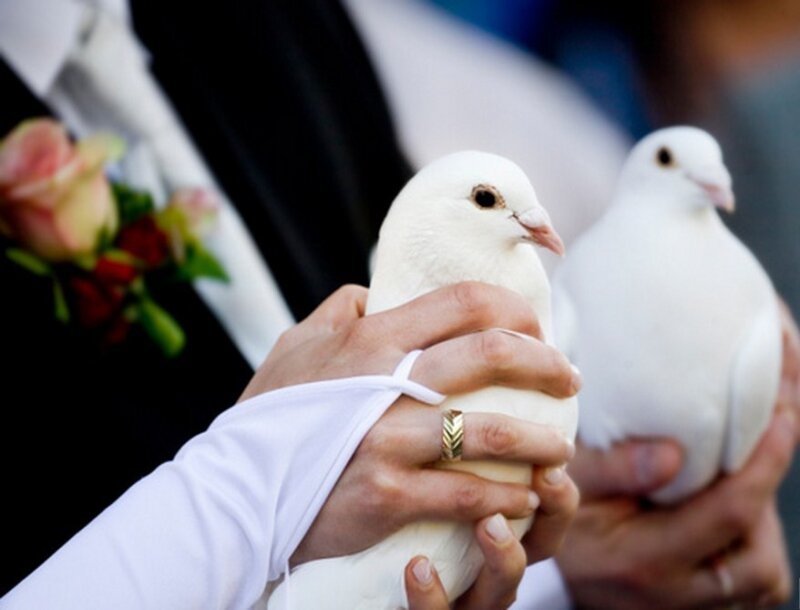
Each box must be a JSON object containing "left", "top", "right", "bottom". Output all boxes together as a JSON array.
[{"left": 722, "top": 299, "right": 781, "bottom": 472}]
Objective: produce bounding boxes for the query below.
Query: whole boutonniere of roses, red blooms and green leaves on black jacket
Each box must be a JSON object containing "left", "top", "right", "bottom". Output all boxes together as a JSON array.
[{"left": 0, "top": 119, "right": 227, "bottom": 356}]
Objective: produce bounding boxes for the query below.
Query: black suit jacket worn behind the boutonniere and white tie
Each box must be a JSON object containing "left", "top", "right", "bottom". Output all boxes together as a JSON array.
[{"left": 0, "top": 0, "right": 409, "bottom": 592}]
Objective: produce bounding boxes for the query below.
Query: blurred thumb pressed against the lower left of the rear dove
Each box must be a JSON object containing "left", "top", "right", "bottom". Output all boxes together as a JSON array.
[{"left": 568, "top": 440, "right": 683, "bottom": 499}]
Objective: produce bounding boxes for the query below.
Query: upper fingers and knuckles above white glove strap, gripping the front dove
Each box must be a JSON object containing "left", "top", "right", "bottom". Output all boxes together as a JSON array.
[{"left": 240, "top": 282, "right": 579, "bottom": 400}]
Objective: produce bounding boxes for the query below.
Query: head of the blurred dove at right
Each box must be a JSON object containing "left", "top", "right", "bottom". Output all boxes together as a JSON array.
[{"left": 620, "top": 126, "right": 734, "bottom": 212}]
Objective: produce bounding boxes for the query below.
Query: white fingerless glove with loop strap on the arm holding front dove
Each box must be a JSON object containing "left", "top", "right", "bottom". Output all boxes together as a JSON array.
[{"left": 0, "top": 351, "right": 445, "bottom": 610}]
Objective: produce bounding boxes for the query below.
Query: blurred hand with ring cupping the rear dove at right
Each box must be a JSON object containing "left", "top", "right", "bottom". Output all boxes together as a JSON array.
[{"left": 557, "top": 409, "right": 796, "bottom": 610}]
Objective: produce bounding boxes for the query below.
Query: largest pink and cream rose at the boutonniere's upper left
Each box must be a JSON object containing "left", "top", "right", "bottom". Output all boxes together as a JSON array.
[{"left": 0, "top": 119, "right": 122, "bottom": 261}]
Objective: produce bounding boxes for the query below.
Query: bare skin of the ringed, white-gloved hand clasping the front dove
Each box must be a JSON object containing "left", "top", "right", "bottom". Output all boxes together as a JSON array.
[{"left": 241, "top": 282, "right": 580, "bottom": 610}]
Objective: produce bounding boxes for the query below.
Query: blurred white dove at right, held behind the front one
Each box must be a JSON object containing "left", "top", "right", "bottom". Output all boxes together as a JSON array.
[{"left": 553, "top": 127, "right": 781, "bottom": 503}]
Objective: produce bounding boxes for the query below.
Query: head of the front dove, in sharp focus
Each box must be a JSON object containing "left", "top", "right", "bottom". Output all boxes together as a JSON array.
[{"left": 392, "top": 151, "right": 564, "bottom": 255}]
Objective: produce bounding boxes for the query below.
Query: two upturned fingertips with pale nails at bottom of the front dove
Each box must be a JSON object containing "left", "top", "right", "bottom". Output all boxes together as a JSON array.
[{"left": 405, "top": 514, "right": 526, "bottom": 610}]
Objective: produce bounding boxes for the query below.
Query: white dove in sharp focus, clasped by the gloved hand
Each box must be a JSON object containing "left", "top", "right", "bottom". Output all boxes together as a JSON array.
[{"left": 270, "top": 151, "right": 577, "bottom": 610}]
